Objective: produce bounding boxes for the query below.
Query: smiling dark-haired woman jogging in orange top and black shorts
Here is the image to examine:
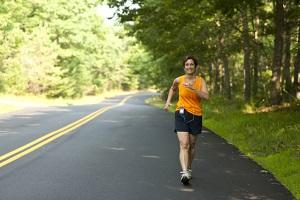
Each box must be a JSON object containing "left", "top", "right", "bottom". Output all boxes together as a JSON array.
[{"left": 164, "top": 56, "right": 209, "bottom": 185}]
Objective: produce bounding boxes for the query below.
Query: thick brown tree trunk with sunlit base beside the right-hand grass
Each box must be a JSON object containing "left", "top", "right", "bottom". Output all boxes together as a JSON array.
[{"left": 271, "top": 0, "right": 284, "bottom": 105}]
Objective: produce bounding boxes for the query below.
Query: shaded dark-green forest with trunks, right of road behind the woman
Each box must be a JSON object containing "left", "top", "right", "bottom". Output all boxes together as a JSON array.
[{"left": 110, "top": 0, "right": 300, "bottom": 106}]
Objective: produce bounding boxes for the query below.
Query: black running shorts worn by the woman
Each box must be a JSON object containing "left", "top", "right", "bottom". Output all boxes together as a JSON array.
[{"left": 174, "top": 110, "right": 202, "bottom": 135}]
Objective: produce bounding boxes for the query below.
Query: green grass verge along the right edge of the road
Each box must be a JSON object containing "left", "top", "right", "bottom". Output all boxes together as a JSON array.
[{"left": 147, "top": 97, "right": 300, "bottom": 200}]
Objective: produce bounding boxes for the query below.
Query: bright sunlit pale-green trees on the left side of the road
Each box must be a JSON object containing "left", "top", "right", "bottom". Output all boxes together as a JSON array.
[{"left": 0, "top": 0, "right": 150, "bottom": 98}]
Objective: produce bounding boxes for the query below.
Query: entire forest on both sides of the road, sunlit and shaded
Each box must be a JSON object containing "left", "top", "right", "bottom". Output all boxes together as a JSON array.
[{"left": 0, "top": 0, "right": 300, "bottom": 106}]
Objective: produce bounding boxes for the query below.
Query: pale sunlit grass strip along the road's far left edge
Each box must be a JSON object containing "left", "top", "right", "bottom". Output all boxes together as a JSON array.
[{"left": 0, "top": 90, "right": 136, "bottom": 114}]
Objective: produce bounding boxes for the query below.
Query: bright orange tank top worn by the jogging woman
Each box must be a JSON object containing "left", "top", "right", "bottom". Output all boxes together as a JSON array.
[{"left": 176, "top": 75, "right": 203, "bottom": 116}]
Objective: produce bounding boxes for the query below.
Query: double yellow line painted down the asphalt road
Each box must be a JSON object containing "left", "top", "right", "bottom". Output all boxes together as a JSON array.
[{"left": 0, "top": 96, "right": 132, "bottom": 168}]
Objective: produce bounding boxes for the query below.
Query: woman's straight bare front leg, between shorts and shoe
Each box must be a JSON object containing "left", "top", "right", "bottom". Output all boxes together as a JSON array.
[{"left": 177, "top": 132, "right": 190, "bottom": 171}]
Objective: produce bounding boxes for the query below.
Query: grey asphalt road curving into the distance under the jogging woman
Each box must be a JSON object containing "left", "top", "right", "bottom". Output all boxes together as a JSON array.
[{"left": 0, "top": 93, "right": 294, "bottom": 200}]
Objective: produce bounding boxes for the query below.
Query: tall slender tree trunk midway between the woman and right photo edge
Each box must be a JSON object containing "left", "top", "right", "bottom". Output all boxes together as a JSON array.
[{"left": 241, "top": 6, "right": 251, "bottom": 102}]
